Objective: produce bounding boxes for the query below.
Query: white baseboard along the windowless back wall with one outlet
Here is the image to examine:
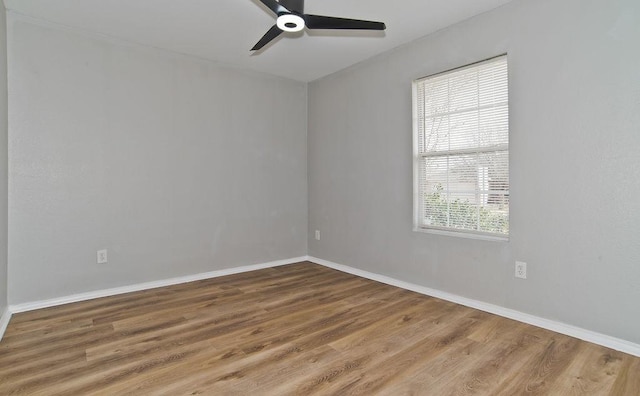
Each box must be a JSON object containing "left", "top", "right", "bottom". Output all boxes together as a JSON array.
[{"left": 9, "top": 256, "right": 307, "bottom": 313}]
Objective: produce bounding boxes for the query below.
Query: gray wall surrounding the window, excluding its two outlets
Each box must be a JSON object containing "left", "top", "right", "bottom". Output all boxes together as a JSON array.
[{"left": 308, "top": 0, "right": 640, "bottom": 343}]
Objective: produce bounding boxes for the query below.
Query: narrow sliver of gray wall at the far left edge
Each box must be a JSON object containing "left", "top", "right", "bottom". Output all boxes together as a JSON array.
[{"left": 0, "top": 3, "right": 8, "bottom": 315}]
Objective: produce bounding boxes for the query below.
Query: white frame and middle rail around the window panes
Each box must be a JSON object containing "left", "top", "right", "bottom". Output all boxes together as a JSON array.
[{"left": 412, "top": 53, "right": 511, "bottom": 242}]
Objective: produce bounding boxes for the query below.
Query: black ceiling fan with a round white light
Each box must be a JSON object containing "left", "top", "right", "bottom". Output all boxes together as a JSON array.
[{"left": 251, "top": 0, "right": 386, "bottom": 51}]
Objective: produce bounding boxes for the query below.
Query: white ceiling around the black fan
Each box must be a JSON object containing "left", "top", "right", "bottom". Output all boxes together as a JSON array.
[{"left": 5, "top": 0, "right": 510, "bottom": 81}]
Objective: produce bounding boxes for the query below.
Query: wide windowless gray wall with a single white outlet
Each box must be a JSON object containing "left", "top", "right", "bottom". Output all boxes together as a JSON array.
[{"left": 7, "top": 13, "right": 308, "bottom": 304}]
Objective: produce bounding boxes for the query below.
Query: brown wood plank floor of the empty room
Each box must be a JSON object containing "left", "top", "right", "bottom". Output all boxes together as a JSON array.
[{"left": 0, "top": 263, "right": 640, "bottom": 395}]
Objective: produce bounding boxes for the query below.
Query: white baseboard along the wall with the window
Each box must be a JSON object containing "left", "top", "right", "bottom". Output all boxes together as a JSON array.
[{"left": 307, "top": 257, "right": 640, "bottom": 357}]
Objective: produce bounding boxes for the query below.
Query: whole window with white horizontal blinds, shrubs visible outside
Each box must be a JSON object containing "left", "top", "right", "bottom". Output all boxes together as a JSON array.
[{"left": 413, "top": 55, "right": 509, "bottom": 239}]
